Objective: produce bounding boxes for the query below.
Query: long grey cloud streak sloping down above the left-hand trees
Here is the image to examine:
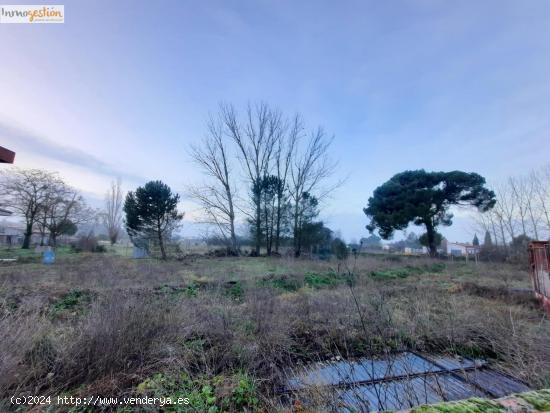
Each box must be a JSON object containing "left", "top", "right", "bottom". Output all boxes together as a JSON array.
[{"left": 0, "top": 122, "right": 145, "bottom": 182}]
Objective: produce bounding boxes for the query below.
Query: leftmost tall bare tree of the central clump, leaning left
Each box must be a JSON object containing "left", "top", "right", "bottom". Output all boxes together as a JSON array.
[{"left": 187, "top": 116, "right": 238, "bottom": 253}]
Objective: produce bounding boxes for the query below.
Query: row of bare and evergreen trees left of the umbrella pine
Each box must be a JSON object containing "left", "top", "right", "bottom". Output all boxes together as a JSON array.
[{"left": 0, "top": 103, "right": 340, "bottom": 258}]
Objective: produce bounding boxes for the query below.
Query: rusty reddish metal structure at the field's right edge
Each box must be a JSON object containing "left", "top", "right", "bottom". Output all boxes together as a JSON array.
[{"left": 529, "top": 241, "right": 550, "bottom": 311}]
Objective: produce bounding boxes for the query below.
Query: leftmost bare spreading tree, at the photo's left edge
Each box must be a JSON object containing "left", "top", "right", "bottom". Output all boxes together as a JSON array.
[{"left": 0, "top": 169, "right": 59, "bottom": 249}]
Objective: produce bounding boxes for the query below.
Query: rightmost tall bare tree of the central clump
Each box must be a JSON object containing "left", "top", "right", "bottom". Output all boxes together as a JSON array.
[{"left": 289, "top": 128, "right": 341, "bottom": 256}]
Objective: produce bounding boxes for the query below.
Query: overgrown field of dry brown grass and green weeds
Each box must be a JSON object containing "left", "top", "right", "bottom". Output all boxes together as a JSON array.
[{"left": 0, "top": 253, "right": 550, "bottom": 412}]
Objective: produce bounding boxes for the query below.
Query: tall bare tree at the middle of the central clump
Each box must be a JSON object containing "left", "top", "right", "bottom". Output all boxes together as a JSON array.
[{"left": 220, "top": 103, "right": 284, "bottom": 255}]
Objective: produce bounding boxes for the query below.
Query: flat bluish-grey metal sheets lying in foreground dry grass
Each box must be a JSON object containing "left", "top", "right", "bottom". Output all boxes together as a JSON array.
[{"left": 285, "top": 352, "right": 529, "bottom": 412}]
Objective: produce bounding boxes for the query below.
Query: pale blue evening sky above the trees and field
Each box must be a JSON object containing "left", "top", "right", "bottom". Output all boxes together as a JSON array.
[{"left": 0, "top": 0, "right": 550, "bottom": 241}]
